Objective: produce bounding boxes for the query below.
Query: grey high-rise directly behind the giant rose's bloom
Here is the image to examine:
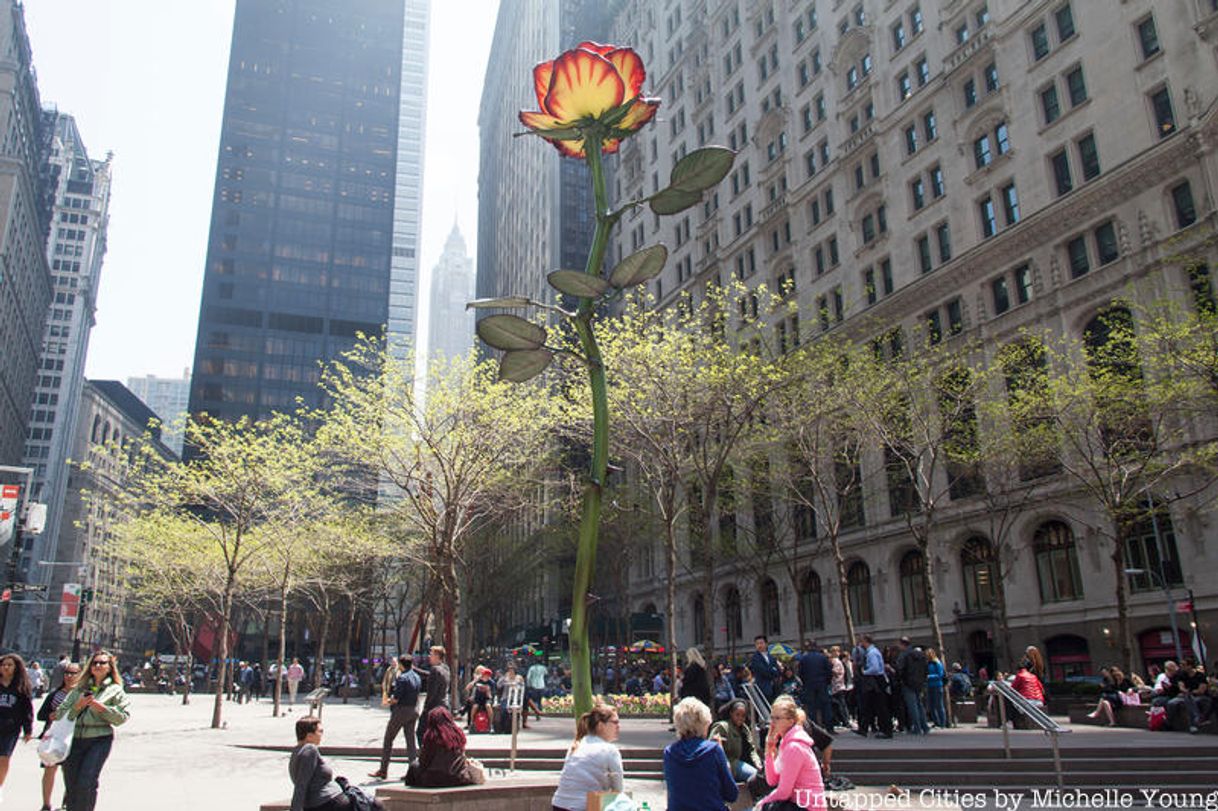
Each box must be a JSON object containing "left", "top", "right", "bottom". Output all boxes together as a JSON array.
[{"left": 476, "top": 0, "right": 609, "bottom": 639}]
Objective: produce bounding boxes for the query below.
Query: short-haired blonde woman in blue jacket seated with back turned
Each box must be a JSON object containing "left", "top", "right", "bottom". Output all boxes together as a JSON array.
[{"left": 664, "top": 698, "right": 739, "bottom": 811}]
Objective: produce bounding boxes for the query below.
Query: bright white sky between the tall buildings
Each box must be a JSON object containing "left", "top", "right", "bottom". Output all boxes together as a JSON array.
[{"left": 24, "top": 0, "right": 498, "bottom": 380}]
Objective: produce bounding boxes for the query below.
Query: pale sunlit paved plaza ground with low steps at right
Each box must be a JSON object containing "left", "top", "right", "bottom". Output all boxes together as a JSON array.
[{"left": 4, "top": 694, "right": 1212, "bottom": 811}]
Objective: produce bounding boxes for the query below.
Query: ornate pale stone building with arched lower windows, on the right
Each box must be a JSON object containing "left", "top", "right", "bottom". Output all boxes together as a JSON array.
[{"left": 610, "top": 0, "right": 1218, "bottom": 679}]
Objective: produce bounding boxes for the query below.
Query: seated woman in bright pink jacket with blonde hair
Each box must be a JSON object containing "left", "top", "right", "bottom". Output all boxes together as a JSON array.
[{"left": 756, "top": 695, "right": 826, "bottom": 811}]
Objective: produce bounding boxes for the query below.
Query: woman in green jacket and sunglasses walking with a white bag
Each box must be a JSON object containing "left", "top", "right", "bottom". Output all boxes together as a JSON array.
[{"left": 55, "top": 650, "right": 130, "bottom": 811}]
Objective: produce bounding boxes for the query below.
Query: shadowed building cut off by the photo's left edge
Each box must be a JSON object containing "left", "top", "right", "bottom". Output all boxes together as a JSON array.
[{"left": 0, "top": 0, "right": 53, "bottom": 465}]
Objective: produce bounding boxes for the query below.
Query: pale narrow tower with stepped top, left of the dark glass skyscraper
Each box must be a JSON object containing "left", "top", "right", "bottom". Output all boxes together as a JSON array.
[{"left": 18, "top": 111, "right": 111, "bottom": 650}]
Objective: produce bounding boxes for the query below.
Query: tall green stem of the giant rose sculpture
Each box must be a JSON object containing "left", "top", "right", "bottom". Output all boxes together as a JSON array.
[{"left": 569, "top": 134, "right": 615, "bottom": 717}]
